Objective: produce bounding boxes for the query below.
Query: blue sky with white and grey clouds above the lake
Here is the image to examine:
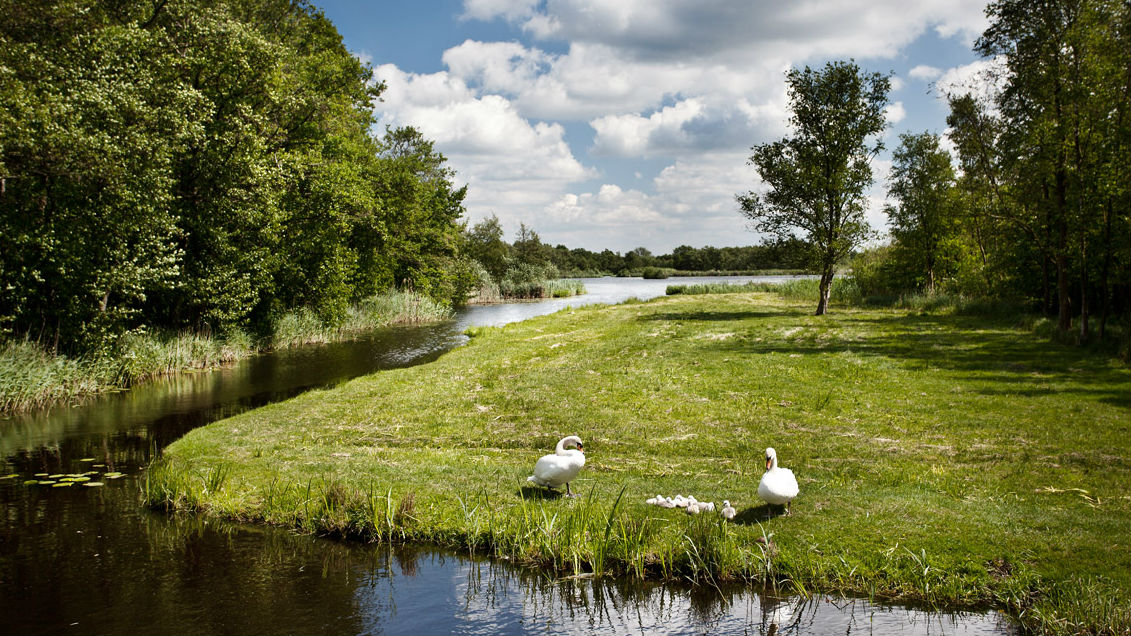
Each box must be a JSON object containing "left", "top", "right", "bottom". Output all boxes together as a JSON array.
[{"left": 313, "top": 0, "right": 986, "bottom": 255}]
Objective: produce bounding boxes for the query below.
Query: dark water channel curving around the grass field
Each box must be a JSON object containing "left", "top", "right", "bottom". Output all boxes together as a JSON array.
[{"left": 0, "top": 278, "right": 1011, "bottom": 634}]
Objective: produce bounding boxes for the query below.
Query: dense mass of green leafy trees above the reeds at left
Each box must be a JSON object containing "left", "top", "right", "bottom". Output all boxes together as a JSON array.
[{"left": 0, "top": 0, "right": 472, "bottom": 352}]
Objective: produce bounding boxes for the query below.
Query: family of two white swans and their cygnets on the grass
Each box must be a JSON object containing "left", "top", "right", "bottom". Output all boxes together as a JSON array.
[{"left": 526, "top": 435, "right": 797, "bottom": 521}]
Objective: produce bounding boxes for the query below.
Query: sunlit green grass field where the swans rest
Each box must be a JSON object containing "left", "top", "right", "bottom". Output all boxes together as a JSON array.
[{"left": 146, "top": 292, "right": 1131, "bottom": 634}]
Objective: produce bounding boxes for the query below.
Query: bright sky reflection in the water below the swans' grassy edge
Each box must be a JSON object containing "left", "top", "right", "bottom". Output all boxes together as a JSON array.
[{"left": 355, "top": 549, "right": 1011, "bottom": 636}]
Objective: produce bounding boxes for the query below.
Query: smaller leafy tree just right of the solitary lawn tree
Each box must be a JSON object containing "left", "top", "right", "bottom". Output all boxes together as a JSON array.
[{"left": 884, "top": 132, "right": 956, "bottom": 294}]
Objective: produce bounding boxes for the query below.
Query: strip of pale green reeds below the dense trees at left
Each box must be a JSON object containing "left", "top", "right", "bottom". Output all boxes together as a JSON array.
[{"left": 0, "top": 291, "right": 450, "bottom": 413}]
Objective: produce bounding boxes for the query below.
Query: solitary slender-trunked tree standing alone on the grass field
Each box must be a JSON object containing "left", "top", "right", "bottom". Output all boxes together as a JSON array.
[{"left": 736, "top": 61, "right": 890, "bottom": 316}]
